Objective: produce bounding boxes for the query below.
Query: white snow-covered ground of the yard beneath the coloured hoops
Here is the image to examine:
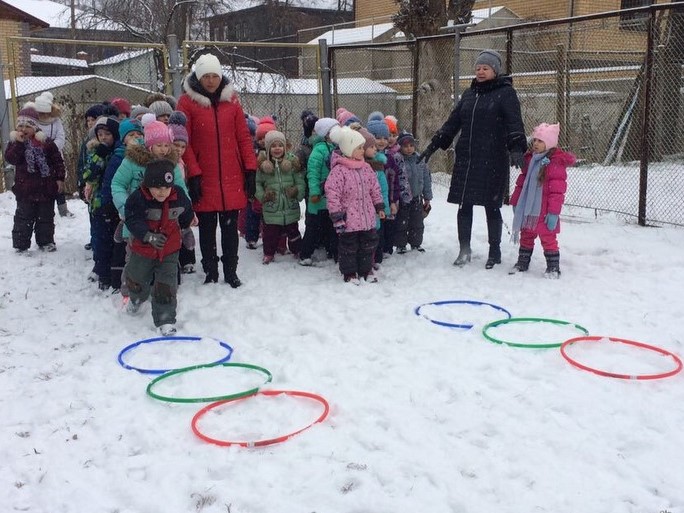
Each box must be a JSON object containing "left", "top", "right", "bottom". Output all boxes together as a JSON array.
[{"left": 0, "top": 177, "right": 684, "bottom": 513}]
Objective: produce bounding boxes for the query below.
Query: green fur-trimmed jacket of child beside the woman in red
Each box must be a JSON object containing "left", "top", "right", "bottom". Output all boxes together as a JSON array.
[{"left": 256, "top": 151, "right": 306, "bottom": 226}]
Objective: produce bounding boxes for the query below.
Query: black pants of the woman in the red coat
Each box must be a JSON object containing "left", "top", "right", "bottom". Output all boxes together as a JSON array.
[{"left": 197, "top": 210, "right": 240, "bottom": 277}]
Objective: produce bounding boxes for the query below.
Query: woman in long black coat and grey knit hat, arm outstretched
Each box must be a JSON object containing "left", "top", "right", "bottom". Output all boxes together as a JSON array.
[{"left": 423, "top": 50, "right": 527, "bottom": 269}]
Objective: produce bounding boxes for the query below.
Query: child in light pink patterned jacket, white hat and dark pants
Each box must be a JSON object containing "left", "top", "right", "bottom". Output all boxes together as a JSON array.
[{"left": 325, "top": 127, "right": 385, "bottom": 283}]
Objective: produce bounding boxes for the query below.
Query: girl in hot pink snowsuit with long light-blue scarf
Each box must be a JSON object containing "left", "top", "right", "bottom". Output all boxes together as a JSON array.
[{"left": 509, "top": 123, "right": 575, "bottom": 278}]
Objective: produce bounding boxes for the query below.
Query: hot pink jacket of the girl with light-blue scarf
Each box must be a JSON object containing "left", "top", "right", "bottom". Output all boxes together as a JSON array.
[{"left": 511, "top": 148, "right": 575, "bottom": 234}]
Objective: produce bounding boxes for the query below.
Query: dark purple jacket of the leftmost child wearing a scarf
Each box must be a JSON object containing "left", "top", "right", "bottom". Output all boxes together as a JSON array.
[{"left": 5, "top": 136, "right": 65, "bottom": 201}]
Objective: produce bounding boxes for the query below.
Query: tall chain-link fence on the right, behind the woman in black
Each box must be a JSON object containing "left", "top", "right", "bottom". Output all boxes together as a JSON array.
[{"left": 330, "top": 5, "right": 684, "bottom": 225}]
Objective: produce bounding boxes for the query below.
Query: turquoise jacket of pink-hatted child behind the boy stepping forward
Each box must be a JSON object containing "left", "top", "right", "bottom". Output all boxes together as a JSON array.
[{"left": 111, "top": 145, "right": 188, "bottom": 237}]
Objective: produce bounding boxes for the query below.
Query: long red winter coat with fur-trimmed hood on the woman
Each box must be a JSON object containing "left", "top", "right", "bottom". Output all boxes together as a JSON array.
[{"left": 176, "top": 72, "right": 257, "bottom": 212}]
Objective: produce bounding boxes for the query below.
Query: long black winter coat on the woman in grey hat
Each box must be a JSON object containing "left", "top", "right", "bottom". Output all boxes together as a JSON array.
[{"left": 432, "top": 76, "right": 527, "bottom": 207}]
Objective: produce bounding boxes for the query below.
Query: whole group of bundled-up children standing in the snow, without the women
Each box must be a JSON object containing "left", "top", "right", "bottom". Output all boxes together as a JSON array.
[{"left": 5, "top": 88, "right": 574, "bottom": 335}]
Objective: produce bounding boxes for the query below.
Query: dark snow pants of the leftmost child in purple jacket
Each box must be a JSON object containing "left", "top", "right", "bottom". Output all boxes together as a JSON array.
[{"left": 12, "top": 198, "right": 55, "bottom": 250}]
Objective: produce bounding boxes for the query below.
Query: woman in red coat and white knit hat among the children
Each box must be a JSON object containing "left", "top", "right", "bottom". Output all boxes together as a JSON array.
[{"left": 177, "top": 54, "right": 257, "bottom": 288}]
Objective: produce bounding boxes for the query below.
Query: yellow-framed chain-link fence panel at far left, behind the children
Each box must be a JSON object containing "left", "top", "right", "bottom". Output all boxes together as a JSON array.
[{"left": 0, "top": 38, "right": 168, "bottom": 193}]
